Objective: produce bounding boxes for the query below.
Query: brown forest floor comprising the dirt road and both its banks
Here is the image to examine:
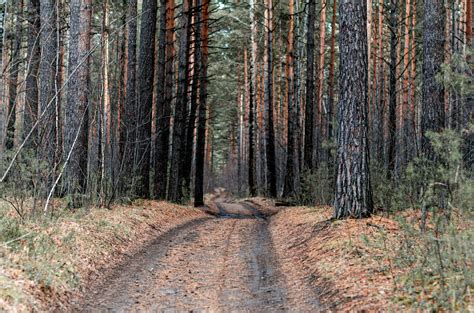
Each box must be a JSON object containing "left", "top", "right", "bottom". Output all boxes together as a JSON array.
[{"left": 0, "top": 194, "right": 404, "bottom": 312}]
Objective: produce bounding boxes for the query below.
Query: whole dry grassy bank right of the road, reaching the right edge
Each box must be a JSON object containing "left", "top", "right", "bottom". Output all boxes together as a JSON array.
[{"left": 271, "top": 207, "right": 474, "bottom": 311}]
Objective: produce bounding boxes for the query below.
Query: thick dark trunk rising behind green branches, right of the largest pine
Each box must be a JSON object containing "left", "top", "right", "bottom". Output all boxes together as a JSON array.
[{"left": 421, "top": 0, "right": 446, "bottom": 160}]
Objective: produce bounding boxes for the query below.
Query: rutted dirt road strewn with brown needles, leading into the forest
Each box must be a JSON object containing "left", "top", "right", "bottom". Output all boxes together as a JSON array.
[{"left": 78, "top": 199, "right": 320, "bottom": 312}]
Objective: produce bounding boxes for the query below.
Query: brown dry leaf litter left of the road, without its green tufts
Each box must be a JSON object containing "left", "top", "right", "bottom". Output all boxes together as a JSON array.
[{"left": 0, "top": 201, "right": 206, "bottom": 311}]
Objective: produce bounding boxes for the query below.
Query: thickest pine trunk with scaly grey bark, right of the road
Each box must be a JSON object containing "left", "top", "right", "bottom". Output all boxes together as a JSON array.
[{"left": 334, "top": 0, "right": 373, "bottom": 218}]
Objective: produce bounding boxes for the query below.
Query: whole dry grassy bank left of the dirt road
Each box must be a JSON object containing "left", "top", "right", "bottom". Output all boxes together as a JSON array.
[{"left": 0, "top": 201, "right": 205, "bottom": 311}]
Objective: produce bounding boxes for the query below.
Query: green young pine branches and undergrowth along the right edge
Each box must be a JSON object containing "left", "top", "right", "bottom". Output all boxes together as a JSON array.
[{"left": 370, "top": 130, "right": 474, "bottom": 311}]
